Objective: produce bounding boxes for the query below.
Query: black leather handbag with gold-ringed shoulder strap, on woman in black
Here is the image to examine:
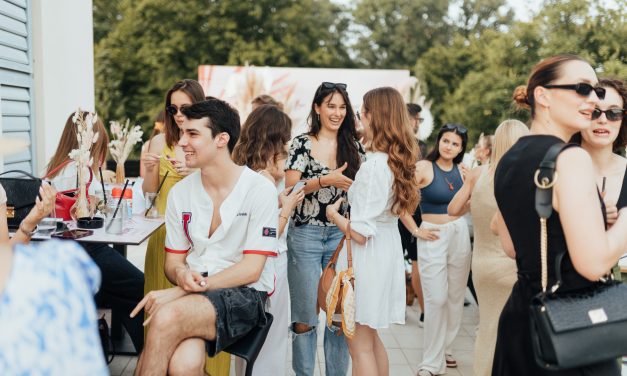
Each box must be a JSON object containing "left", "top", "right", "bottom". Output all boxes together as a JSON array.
[{"left": 530, "top": 144, "right": 627, "bottom": 370}]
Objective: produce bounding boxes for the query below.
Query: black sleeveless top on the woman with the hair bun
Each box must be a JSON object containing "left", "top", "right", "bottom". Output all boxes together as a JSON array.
[{"left": 494, "top": 135, "right": 603, "bottom": 294}]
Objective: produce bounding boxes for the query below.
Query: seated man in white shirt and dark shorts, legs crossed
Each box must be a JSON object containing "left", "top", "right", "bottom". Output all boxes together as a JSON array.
[{"left": 133, "top": 99, "right": 278, "bottom": 375}]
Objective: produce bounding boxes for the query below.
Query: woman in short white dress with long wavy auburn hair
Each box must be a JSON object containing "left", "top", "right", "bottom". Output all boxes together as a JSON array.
[{"left": 326, "top": 87, "right": 419, "bottom": 376}]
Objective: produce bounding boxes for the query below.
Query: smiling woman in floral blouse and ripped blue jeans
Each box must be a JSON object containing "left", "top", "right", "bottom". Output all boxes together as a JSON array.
[{"left": 285, "top": 82, "right": 365, "bottom": 376}]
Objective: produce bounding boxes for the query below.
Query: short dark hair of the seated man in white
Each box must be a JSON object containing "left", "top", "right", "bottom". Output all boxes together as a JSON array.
[{"left": 181, "top": 99, "right": 240, "bottom": 153}]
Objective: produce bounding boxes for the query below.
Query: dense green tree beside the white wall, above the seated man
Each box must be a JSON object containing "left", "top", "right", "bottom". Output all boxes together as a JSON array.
[{"left": 94, "top": 0, "right": 353, "bottom": 134}]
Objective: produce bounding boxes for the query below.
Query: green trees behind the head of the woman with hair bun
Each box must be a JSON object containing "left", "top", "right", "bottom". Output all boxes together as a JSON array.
[{"left": 415, "top": 0, "right": 627, "bottom": 142}]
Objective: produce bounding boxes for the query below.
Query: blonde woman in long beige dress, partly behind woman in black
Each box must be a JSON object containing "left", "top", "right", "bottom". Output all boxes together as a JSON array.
[{"left": 448, "top": 120, "right": 529, "bottom": 376}]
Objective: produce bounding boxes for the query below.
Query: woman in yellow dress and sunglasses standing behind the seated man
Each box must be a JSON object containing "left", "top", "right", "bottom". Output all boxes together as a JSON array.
[{"left": 141, "top": 79, "right": 230, "bottom": 375}]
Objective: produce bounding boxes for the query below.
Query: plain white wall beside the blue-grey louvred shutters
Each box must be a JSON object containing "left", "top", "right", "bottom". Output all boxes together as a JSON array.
[{"left": 32, "top": 0, "right": 95, "bottom": 173}]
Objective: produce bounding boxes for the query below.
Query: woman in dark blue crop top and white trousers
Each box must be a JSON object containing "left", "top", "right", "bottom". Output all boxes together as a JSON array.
[{"left": 408, "top": 124, "right": 470, "bottom": 376}]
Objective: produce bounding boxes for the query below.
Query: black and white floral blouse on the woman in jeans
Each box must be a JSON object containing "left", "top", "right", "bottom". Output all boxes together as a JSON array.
[{"left": 285, "top": 133, "right": 366, "bottom": 226}]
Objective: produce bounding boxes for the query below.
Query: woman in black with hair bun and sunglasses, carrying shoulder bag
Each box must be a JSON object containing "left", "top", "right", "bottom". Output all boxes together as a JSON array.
[{"left": 492, "top": 55, "right": 627, "bottom": 376}]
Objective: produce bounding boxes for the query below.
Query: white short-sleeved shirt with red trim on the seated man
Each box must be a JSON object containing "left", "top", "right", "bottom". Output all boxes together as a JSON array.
[{"left": 165, "top": 167, "right": 278, "bottom": 292}]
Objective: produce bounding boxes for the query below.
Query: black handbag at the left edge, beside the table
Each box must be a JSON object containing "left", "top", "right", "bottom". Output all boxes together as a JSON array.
[{"left": 0, "top": 170, "right": 41, "bottom": 229}]
